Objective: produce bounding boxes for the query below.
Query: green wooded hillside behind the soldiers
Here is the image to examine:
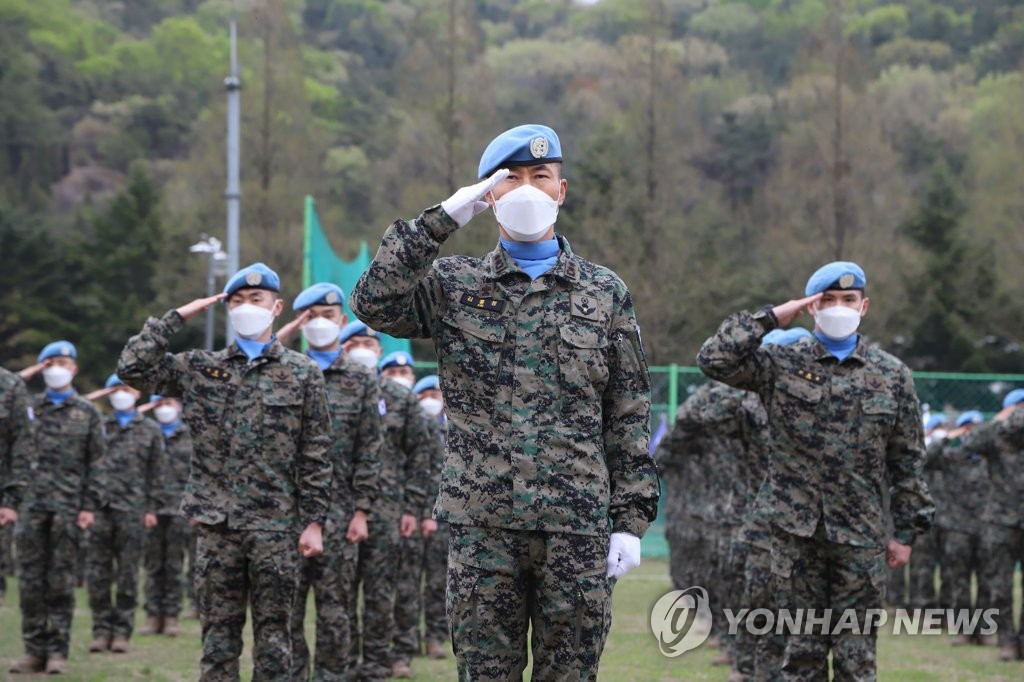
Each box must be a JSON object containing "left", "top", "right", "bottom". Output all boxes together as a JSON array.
[{"left": 0, "top": 0, "right": 1024, "bottom": 383}]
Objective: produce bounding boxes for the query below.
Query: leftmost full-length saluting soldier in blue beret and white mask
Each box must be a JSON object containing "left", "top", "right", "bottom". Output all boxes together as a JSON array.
[{"left": 10, "top": 341, "right": 105, "bottom": 675}]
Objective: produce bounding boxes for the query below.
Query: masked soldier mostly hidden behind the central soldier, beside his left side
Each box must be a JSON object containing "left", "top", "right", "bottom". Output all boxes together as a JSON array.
[{"left": 413, "top": 374, "right": 451, "bottom": 659}]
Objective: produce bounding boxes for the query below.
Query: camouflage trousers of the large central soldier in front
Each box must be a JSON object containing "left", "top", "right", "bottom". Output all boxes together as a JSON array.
[{"left": 447, "top": 525, "right": 613, "bottom": 682}]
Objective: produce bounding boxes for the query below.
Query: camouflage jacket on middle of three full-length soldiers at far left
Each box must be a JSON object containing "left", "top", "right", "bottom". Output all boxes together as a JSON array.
[{"left": 98, "top": 413, "right": 165, "bottom": 512}]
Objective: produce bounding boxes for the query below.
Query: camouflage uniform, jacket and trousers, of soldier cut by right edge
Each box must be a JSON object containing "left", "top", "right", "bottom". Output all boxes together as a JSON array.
[{"left": 964, "top": 407, "right": 1024, "bottom": 651}]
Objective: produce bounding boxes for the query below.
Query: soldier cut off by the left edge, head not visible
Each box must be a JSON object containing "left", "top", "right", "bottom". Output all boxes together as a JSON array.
[{"left": 0, "top": 368, "right": 32, "bottom": 606}]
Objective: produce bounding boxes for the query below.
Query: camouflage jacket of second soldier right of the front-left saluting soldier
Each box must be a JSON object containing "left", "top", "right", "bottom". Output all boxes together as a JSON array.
[{"left": 377, "top": 377, "right": 436, "bottom": 518}]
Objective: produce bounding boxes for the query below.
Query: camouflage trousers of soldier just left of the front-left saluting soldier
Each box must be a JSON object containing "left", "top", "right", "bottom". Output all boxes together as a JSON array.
[{"left": 142, "top": 514, "right": 189, "bottom": 619}]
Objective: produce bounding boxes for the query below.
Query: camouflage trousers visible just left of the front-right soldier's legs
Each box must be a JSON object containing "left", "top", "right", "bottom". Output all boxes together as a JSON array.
[{"left": 735, "top": 545, "right": 785, "bottom": 682}]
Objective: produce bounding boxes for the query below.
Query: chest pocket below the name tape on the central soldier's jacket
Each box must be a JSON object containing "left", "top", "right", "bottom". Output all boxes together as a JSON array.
[{"left": 438, "top": 310, "right": 506, "bottom": 419}]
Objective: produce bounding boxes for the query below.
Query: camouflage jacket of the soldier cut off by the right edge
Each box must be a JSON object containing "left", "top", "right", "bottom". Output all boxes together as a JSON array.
[{"left": 964, "top": 408, "right": 1024, "bottom": 527}]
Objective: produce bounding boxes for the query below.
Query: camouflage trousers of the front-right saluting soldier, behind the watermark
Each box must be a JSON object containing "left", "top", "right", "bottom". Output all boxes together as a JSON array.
[{"left": 771, "top": 522, "right": 888, "bottom": 682}]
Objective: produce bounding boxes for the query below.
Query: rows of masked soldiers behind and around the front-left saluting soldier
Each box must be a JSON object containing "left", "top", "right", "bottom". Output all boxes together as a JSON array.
[{"left": 0, "top": 299, "right": 449, "bottom": 680}]
